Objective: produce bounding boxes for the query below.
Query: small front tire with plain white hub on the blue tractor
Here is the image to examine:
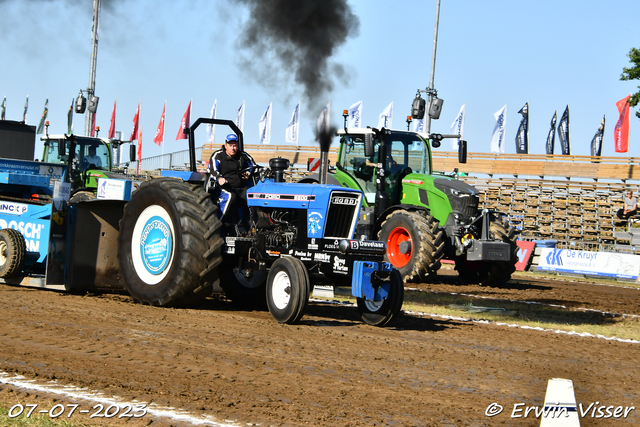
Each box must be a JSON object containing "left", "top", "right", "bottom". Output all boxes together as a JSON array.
[{"left": 267, "top": 257, "right": 311, "bottom": 325}]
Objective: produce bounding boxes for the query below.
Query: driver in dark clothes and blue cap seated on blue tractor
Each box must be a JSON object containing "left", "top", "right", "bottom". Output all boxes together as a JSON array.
[{"left": 206, "top": 133, "right": 256, "bottom": 230}]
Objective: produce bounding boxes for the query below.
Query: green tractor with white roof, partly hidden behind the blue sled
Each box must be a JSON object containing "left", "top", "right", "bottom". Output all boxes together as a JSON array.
[{"left": 42, "top": 134, "right": 135, "bottom": 203}]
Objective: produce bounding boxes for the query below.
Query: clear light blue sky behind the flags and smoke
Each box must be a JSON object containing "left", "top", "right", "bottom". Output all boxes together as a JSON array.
[{"left": 0, "top": 0, "right": 640, "bottom": 162}]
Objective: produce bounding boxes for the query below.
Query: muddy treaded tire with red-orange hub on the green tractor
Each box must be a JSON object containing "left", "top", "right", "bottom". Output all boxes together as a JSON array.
[{"left": 378, "top": 210, "right": 444, "bottom": 282}]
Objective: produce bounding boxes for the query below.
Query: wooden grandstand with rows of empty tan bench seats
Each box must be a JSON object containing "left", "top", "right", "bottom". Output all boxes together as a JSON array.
[{"left": 202, "top": 144, "right": 640, "bottom": 252}]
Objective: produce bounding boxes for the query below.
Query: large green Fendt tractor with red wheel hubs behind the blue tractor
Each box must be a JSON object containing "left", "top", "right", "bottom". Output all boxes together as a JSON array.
[{"left": 303, "top": 128, "right": 517, "bottom": 285}]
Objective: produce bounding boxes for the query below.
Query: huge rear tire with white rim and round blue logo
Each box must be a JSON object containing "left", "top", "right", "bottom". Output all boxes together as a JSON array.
[{"left": 118, "top": 178, "right": 222, "bottom": 307}]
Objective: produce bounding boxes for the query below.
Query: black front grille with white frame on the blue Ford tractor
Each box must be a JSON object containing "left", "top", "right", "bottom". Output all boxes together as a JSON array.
[{"left": 324, "top": 191, "right": 361, "bottom": 239}]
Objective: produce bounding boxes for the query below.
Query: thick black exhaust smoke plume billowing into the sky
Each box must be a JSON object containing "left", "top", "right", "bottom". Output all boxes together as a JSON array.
[{"left": 234, "top": 0, "right": 360, "bottom": 111}]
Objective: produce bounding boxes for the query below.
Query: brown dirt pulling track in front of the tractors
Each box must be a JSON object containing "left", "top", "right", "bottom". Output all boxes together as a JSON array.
[{"left": 0, "top": 276, "right": 640, "bottom": 426}]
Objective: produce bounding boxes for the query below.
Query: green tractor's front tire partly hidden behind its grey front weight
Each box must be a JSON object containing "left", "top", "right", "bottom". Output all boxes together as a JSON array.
[{"left": 455, "top": 218, "right": 518, "bottom": 286}]
